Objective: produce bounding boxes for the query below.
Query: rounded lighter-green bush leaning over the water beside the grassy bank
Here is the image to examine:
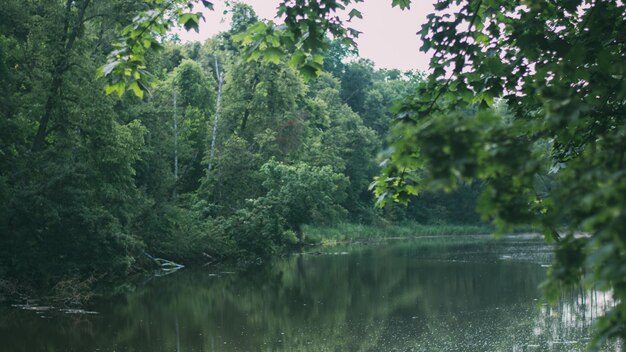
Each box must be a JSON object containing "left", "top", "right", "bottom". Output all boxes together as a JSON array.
[{"left": 218, "top": 159, "right": 349, "bottom": 259}]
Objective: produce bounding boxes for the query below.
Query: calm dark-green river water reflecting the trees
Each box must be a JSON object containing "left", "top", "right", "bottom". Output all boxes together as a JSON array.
[{"left": 0, "top": 237, "right": 620, "bottom": 351}]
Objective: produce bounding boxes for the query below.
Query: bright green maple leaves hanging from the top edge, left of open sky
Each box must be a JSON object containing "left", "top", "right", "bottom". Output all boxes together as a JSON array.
[{"left": 97, "top": 0, "right": 372, "bottom": 86}]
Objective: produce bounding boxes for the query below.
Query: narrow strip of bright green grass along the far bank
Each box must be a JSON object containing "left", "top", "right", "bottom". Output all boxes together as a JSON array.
[{"left": 303, "top": 222, "right": 494, "bottom": 244}]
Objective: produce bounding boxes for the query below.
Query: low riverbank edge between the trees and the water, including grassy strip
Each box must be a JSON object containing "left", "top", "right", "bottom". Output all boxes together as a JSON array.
[{"left": 0, "top": 222, "right": 532, "bottom": 306}]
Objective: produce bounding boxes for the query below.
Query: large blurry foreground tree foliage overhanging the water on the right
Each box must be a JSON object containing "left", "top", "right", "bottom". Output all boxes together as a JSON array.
[{"left": 366, "top": 0, "right": 626, "bottom": 346}]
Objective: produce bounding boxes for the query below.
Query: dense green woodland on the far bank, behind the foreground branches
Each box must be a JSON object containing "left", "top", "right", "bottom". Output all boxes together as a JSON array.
[{"left": 0, "top": 0, "right": 477, "bottom": 290}]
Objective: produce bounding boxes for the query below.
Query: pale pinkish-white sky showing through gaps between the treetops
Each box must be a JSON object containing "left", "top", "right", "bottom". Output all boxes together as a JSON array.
[{"left": 179, "top": 0, "right": 434, "bottom": 71}]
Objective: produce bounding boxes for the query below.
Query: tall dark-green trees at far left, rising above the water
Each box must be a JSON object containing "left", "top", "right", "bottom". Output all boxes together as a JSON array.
[{"left": 0, "top": 0, "right": 156, "bottom": 283}]
